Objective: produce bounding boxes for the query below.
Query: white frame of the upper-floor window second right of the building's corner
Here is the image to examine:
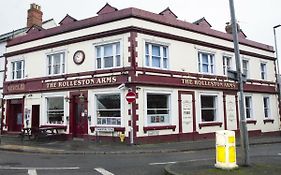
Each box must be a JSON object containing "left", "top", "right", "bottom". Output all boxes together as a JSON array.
[{"left": 198, "top": 51, "right": 216, "bottom": 75}]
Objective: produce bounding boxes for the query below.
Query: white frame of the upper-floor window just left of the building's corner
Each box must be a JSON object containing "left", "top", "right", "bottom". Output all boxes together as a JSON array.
[{"left": 94, "top": 40, "right": 123, "bottom": 70}]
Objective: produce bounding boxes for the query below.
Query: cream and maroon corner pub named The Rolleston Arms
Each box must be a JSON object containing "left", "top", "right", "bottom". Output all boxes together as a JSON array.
[{"left": 1, "top": 4, "right": 280, "bottom": 143}]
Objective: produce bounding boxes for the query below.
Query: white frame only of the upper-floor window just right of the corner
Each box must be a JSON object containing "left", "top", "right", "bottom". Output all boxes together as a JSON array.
[{"left": 144, "top": 41, "right": 170, "bottom": 70}]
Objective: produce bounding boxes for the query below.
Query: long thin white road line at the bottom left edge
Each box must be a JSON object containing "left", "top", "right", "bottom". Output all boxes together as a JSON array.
[{"left": 0, "top": 166, "right": 80, "bottom": 170}]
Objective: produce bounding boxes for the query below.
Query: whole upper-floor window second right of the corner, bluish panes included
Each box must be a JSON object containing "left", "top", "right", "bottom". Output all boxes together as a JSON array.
[{"left": 198, "top": 52, "right": 214, "bottom": 74}]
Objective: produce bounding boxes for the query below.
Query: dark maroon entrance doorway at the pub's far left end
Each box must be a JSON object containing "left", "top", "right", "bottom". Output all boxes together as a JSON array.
[{"left": 7, "top": 100, "right": 23, "bottom": 132}]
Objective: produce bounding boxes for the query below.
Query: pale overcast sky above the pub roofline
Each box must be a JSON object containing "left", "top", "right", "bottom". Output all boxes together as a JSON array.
[{"left": 0, "top": 0, "right": 281, "bottom": 47}]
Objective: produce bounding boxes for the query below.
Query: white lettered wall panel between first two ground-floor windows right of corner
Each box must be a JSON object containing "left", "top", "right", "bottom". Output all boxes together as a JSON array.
[{"left": 181, "top": 94, "right": 193, "bottom": 133}]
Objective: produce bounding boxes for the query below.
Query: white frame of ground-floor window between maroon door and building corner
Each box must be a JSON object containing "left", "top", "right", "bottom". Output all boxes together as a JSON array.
[{"left": 93, "top": 91, "right": 124, "bottom": 127}]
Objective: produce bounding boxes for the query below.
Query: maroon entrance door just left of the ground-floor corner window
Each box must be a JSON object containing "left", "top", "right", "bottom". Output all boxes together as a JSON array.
[{"left": 70, "top": 95, "right": 88, "bottom": 137}]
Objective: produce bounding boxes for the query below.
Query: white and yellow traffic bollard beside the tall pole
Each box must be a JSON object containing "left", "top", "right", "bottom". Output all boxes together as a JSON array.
[{"left": 215, "top": 130, "right": 238, "bottom": 169}]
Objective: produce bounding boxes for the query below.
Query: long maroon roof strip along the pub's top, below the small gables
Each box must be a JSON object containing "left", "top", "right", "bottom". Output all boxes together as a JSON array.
[{"left": 7, "top": 8, "right": 274, "bottom": 52}]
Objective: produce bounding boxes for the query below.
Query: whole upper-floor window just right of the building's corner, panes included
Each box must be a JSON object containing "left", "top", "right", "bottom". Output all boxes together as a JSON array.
[{"left": 145, "top": 43, "right": 169, "bottom": 69}]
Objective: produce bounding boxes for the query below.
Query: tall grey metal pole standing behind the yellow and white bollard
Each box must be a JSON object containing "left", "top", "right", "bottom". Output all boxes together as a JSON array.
[{"left": 229, "top": 0, "right": 250, "bottom": 166}]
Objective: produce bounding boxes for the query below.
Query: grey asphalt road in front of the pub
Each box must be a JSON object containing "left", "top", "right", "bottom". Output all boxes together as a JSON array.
[{"left": 0, "top": 143, "right": 281, "bottom": 175}]
